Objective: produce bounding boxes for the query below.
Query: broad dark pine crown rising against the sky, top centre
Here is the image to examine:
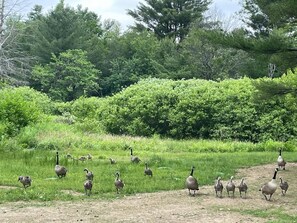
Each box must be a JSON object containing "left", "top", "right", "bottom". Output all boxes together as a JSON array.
[{"left": 128, "top": 0, "right": 210, "bottom": 41}]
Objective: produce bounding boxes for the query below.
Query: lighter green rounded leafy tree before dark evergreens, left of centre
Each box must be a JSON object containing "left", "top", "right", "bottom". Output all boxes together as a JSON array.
[{"left": 31, "top": 50, "right": 100, "bottom": 101}]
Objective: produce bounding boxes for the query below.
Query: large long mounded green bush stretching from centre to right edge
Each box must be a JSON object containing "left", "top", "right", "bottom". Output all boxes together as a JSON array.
[{"left": 98, "top": 78, "right": 297, "bottom": 142}]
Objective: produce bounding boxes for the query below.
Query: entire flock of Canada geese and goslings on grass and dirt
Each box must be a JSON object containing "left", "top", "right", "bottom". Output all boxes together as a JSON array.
[{"left": 18, "top": 148, "right": 289, "bottom": 200}]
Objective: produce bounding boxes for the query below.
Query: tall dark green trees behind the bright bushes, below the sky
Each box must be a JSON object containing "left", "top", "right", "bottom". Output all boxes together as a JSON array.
[{"left": 0, "top": 0, "right": 297, "bottom": 101}]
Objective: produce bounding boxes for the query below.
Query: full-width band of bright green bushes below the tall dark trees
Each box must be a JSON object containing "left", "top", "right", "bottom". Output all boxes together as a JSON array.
[{"left": 0, "top": 72, "right": 297, "bottom": 142}]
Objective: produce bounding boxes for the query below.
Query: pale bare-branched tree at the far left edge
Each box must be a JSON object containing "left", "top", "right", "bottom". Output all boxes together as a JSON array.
[{"left": 0, "top": 0, "right": 32, "bottom": 84}]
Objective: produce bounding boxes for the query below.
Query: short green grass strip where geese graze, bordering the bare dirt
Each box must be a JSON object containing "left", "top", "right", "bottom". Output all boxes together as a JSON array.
[{"left": 0, "top": 149, "right": 297, "bottom": 202}]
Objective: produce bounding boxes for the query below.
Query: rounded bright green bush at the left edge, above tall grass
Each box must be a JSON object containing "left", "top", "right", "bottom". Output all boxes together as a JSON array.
[{"left": 0, "top": 87, "right": 51, "bottom": 140}]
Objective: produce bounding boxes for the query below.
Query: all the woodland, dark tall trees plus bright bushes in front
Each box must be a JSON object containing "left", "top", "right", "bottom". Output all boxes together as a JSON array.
[{"left": 0, "top": 0, "right": 297, "bottom": 143}]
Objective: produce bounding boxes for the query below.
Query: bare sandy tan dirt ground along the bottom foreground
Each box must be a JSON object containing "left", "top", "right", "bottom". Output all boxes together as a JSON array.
[{"left": 0, "top": 163, "right": 297, "bottom": 223}]
